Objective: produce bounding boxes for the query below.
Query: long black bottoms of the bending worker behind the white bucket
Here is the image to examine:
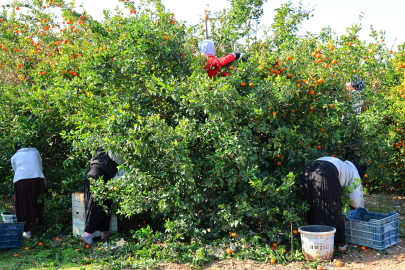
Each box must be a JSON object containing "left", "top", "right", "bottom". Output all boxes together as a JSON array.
[{"left": 300, "top": 160, "right": 346, "bottom": 245}]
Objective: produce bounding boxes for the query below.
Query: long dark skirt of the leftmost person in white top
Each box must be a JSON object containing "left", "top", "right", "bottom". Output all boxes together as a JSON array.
[{"left": 14, "top": 178, "right": 45, "bottom": 232}]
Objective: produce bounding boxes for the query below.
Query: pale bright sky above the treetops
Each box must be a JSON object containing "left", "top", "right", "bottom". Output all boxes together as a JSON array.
[{"left": 72, "top": 0, "right": 405, "bottom": 49}]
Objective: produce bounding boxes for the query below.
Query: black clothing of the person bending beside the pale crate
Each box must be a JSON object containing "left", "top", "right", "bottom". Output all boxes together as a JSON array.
[{"left": 84, "top": 164, "right": 112, "bottom": 234}]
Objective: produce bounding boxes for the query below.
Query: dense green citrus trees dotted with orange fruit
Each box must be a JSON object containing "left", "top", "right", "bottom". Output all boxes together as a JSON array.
[{"left": 0, "top": 1, "right": 405, "bottom": 245}]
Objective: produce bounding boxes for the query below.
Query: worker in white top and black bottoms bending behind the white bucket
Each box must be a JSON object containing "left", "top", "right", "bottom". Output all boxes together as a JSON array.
[{"left": 299, "top": 156, "right": 367, "bottom": 251}]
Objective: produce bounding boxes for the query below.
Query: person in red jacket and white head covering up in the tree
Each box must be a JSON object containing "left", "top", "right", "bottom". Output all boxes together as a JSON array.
[{"left": 198, "top": 39, "right": 240, "bottom": 78}]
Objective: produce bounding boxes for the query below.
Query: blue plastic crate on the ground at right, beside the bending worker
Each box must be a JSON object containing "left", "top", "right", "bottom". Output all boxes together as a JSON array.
[{"left": 343, "top": 208, "right": 399, "bottom": 250}]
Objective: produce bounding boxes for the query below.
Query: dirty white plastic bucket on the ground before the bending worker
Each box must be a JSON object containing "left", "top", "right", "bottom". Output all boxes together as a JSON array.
[{"left": 298, "top": 225, "right": 336, "bottom": 261}]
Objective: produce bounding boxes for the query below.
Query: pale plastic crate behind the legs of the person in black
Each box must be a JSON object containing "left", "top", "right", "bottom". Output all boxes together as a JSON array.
[{"left": 72, "top": 192, "right": 118, "bottom": 237}]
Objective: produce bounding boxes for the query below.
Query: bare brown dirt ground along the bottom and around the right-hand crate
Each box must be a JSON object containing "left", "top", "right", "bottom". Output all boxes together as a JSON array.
[{"left": 156, "top": 194, "right": 405, "bottom": 270}]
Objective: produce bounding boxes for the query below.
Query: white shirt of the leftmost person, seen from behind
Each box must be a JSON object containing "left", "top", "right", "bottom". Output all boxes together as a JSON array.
[{"left": 11, "top": 148, "right": 45, "bottom": 183}]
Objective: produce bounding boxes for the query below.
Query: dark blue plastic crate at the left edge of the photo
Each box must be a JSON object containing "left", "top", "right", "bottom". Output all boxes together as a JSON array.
[{"left": 0, "top": 222, "right": 24, "bottom": 250}]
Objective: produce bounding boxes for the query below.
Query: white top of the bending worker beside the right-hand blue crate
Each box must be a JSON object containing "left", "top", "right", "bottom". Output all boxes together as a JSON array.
[{"left": 317, "top": 157, "right": 363, "bottom": 208}]
